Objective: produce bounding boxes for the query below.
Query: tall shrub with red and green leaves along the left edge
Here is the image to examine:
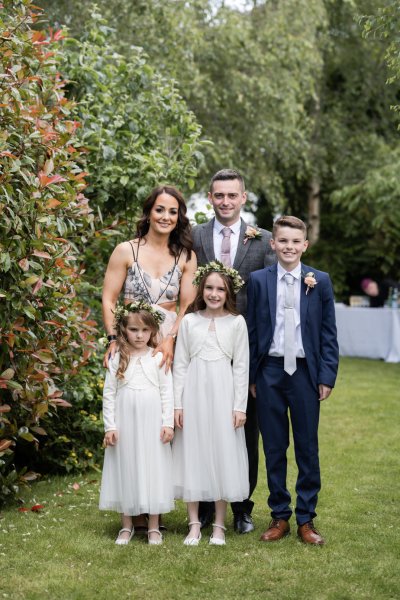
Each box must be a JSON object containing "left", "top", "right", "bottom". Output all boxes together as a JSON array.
[{"left": 0, "top": 0, "right": 95, "bottom": 501}]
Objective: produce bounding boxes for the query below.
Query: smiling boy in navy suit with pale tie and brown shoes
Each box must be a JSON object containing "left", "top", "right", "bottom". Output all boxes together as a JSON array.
[{"left": 247, "top": 216, "right": 339, "bottom": 544}]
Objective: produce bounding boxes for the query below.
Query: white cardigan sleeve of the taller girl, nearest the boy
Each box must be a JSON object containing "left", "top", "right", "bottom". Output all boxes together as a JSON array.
[{"left": 232, "top": 316, "right": 249, "bottom": 412}]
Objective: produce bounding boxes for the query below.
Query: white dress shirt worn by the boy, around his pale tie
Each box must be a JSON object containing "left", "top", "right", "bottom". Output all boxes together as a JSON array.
[{"left": 268, "top": 263, "right": 305, "bottom": 358}]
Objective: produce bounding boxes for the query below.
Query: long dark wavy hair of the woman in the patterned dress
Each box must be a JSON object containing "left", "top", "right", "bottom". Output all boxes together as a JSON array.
[{"left": 136, "top": 185, "right": 193, "bottom": 260}]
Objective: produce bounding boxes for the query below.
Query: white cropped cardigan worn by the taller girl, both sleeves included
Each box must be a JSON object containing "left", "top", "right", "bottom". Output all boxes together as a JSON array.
[{"left": 173, "top": 313, "right": 249, "bottom": 412}]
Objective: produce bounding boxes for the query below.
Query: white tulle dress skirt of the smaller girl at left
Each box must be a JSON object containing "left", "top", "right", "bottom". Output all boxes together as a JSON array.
[{"left": 99, "top": 387, "right": 174, "bottom": 516}]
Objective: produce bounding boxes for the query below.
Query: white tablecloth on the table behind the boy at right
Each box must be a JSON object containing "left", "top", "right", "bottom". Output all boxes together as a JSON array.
[{"left": 335, "top": 304, "right": 400, "bottom": 362}]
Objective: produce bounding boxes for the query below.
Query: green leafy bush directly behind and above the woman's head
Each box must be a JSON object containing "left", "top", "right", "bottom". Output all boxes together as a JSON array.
[{"left": 64, "top": 12, "right": 202, "bottom": 223}]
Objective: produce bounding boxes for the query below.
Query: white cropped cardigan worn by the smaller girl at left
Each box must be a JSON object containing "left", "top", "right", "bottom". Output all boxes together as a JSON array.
[{"left": 103, "top": 349, "right": 174, "bottom": 431}]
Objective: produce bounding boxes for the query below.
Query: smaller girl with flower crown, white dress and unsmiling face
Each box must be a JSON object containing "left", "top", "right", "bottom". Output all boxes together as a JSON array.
[{"left": 99, "top": 300, "right": 174, "bottom": 545}]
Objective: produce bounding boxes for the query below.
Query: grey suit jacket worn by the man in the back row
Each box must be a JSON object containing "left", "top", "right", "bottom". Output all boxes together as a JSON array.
[{"left": 192, "top": 219, "right": 276, "bottom": 316}]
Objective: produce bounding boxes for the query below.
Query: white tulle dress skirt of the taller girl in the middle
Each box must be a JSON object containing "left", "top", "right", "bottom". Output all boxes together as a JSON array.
[{"left": 172, "top": 357, "right": 249, "bottom": 502}]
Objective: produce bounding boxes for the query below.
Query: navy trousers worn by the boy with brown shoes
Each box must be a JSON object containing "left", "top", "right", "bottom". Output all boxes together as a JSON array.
[{"left": 256, "top": 356, "right": 321, "bottom": 525}]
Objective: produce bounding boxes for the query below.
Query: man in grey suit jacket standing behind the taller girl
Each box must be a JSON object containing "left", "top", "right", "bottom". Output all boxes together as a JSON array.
[{"left": 193, "top": 169, "right": 276, "bottom": 533}]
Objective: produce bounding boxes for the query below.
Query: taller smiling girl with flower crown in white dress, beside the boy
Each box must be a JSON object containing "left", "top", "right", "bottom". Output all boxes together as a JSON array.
[{"left": 172, "top": 261, "right": 249, "bottom": 546}]
